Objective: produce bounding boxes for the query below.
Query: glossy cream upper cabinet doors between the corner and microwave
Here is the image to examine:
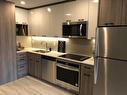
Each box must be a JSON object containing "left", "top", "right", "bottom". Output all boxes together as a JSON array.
[{"left": 29, "top": 5, "right": 63, "bottom": 36}]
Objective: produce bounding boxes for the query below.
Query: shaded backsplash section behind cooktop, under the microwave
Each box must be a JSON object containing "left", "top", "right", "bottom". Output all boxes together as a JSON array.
[{"left": 66, "top": 39, "right": 93, "bottom": 56}]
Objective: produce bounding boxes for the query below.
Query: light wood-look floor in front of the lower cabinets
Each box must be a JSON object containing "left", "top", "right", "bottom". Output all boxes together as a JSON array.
[{"left": 0, "top": 76, "right": 74, "bottom": 95}]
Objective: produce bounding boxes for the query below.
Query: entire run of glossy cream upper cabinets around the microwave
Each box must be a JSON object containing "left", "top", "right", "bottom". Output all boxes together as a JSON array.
[{"left": 16, "top": 0, "right": 98, "bottom": 39}]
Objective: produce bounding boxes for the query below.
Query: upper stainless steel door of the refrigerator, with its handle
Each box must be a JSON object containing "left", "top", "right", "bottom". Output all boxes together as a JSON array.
[{"left": 95, "top": 27, "right": 127, "bottom": 60}]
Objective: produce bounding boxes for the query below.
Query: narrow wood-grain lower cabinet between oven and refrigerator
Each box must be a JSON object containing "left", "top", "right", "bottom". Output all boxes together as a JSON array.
[{"left": 79, "top": 64, "right": 94, "bottom": 95}]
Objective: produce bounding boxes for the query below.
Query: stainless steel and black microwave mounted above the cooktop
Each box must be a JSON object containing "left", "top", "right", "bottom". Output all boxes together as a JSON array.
[{"left": 62, "top": 21, "right": 88, "bottom": 38}]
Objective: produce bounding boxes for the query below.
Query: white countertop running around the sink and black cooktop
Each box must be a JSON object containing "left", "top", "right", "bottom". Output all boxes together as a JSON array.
[{"left": 17, "top": 48, "right": 94, "bottom": 66}]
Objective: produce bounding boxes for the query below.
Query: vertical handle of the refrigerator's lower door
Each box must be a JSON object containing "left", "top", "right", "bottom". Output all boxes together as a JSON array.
[{"left": 94, "top": 59, "right": 99, "bottom": 84}]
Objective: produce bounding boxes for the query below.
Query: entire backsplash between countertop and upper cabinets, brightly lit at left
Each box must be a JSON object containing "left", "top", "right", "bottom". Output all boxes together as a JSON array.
[{"left": 17, "top": 36, "right": 93, "bottom": 56}]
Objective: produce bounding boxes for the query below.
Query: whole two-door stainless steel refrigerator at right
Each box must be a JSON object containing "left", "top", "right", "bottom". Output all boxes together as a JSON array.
[{"left": 93, "top": 27, "right": 127, "bottom": 95}]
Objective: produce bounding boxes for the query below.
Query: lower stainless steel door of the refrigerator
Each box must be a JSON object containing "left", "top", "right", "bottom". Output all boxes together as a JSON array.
[{"left": 93, "top": 58, "right": 127, "bottom": 95}]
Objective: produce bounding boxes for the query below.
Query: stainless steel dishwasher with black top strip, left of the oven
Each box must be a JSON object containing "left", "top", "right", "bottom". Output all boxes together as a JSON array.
[{"left": 42, "top": 56, "right": 56, "bottom": 83}]
